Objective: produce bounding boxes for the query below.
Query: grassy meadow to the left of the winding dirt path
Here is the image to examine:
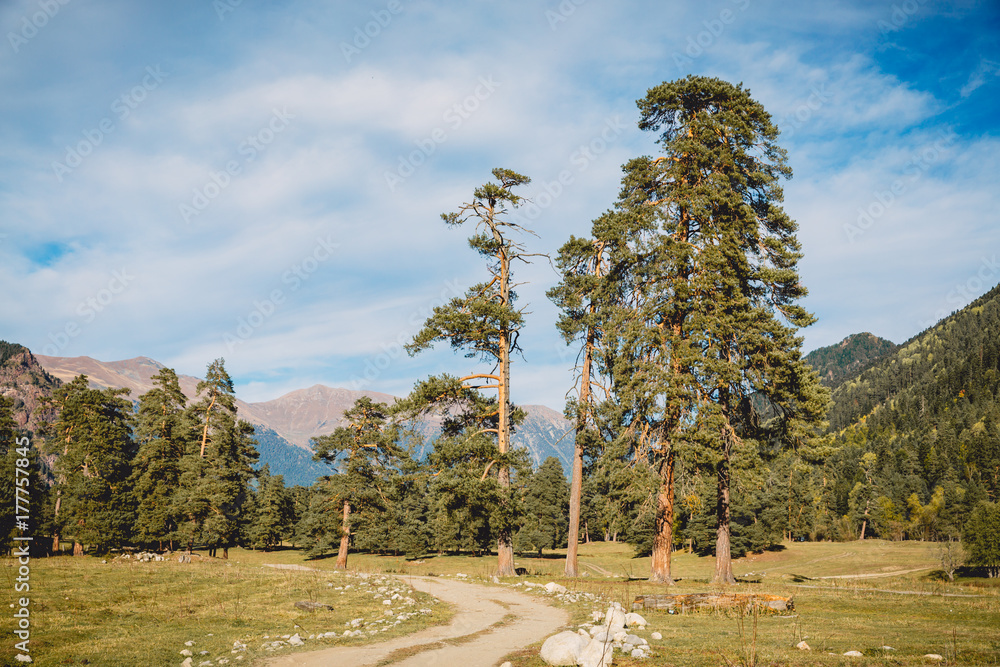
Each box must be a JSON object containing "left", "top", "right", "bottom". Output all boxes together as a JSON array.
[{"left": 0, "top": 549, "right": 451, "bottom": 667}]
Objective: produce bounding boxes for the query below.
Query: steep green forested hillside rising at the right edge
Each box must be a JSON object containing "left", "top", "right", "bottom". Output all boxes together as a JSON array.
[{"left": 829, "top": 286, "right": 1000, "bottom": 509}]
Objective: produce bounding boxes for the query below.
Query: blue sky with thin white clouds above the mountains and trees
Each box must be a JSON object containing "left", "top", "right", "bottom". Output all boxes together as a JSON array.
[{"left": 0, "top": 0, "right": 1000, "bottom": 410}]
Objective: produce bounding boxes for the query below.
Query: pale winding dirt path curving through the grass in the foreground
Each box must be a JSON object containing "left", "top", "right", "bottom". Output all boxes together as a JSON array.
[{"left": 265, "top": 568, "right": 569, "bottom": 667}]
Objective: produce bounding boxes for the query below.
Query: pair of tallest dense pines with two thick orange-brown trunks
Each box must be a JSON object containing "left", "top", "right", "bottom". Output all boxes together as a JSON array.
[{"left": 598, "top": 76, "right": 825, "bottom": 582}]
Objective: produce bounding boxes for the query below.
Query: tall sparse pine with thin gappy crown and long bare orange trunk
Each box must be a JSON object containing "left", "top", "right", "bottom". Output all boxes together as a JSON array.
[{"left": 407, "top": 169, "right": 531, "bottom": 576}]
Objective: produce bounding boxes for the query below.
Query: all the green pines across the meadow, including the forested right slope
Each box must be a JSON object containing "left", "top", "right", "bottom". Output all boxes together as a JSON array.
[{"left": 1, "top": 76, "right": 1000, "bottom": 583}]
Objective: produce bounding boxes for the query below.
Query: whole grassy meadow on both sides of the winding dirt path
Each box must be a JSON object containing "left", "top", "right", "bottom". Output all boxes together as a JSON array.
[{"left": 0, "top": 540, "right": 1000, "bottom": 667}]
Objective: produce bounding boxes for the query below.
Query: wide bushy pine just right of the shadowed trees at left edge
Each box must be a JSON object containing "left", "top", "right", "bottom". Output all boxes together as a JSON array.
[{"left": 48, "top": 375, "right": 136, "bottom": 555}]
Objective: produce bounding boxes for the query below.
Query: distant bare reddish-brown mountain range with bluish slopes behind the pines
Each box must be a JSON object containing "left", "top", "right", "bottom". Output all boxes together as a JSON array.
[{"left": 37, "top": 355, "right": 573, "bottom": 485}]
